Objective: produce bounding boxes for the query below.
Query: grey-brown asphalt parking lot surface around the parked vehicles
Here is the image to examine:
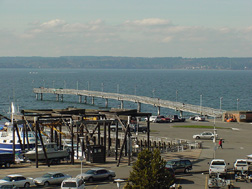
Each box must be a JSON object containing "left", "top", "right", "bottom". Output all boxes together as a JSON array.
[{"left": 0, "top": 120, "right": 252, "bottom": 189}]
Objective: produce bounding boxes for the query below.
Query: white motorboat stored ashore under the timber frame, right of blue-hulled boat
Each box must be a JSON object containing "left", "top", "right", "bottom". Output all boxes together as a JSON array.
[{"left": 24, "top": 142, "right": 69, "bottom": 161}]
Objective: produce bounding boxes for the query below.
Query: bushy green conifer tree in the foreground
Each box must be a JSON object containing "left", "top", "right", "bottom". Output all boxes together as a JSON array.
[{"left": 125, "top": 149, "right": 174, "bottom": 189}]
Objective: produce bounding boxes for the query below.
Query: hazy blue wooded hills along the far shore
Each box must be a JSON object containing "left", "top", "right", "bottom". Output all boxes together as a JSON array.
[{"left": 0, "top": 56, "right": 252, "bottom": 70}]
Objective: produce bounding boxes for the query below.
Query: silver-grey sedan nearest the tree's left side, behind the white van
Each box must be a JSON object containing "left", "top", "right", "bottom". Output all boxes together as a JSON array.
[{"left": 76, "top": 168, "right": 116, "bottom": 182}]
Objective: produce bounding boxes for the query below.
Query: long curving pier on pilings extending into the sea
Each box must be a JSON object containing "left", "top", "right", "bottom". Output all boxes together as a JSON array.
[{"left": 33, "top": 87, "right": 226, "bottom": 117}]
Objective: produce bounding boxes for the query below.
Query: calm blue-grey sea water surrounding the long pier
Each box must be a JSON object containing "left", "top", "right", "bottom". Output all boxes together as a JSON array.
[{"left": 0, "top": 69, "right": 252, "bottom": 116}]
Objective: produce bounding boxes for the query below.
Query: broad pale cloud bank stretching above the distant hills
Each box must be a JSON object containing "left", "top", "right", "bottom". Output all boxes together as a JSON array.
[{"left": 0, "top": 18, "right": 252, "bottom": 57}]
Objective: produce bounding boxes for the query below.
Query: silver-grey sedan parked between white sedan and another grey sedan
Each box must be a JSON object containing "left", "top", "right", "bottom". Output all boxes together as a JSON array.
[{"left": 34, "top": 172, "right": 71, "bottom": 187}]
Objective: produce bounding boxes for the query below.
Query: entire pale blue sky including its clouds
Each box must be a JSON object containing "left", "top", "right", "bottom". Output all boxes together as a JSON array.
[{"left": 0, "top": 0, "right": 252, "bottom": 58}]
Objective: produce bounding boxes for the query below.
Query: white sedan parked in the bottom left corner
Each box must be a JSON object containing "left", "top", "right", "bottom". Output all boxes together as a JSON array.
[{"left": 0, "top": 174, "right": 34, "bottom": 188}]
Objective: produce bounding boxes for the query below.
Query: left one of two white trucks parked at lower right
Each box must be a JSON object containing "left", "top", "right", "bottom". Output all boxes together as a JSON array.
[{"left": 209, "top": 159, "right": 227, "bottom": 178}]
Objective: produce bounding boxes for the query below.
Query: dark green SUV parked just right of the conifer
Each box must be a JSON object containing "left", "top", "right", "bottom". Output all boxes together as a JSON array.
[{"left": 165, "top": 159, "right": 192, "bottom": 173}]
